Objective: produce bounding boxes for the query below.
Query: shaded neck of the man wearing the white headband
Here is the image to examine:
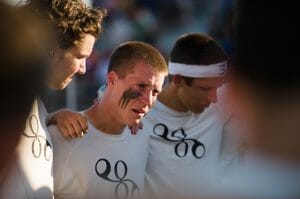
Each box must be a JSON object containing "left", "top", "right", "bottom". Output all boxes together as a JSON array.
[{"left": 157, "top": 83, "right": 188, "bottom": 112}]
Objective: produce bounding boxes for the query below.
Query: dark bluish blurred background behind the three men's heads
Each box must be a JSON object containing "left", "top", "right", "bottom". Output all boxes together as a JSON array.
[{"left": 7, "top": 0, "right": 234, "bottom": 112}]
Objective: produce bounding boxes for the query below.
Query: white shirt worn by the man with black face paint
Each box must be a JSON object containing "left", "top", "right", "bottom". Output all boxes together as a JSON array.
[{"left": 49, "top": 118, "right": 149, "bottom": 199}]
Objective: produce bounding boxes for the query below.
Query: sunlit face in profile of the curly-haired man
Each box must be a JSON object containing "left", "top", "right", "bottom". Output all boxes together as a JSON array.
[{"left": 48, "top": 34, "right": 95, "bottom": 90}]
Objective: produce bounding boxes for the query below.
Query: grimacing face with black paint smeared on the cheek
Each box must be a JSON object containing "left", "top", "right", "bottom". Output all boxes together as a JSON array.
[{"left": 114, "top": 62, "right": 166, "bottom": 126}]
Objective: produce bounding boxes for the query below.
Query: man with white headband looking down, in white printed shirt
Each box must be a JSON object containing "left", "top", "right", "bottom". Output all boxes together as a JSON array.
[{"left": 142, "top": 33, "right": 243, "bottom": 198}]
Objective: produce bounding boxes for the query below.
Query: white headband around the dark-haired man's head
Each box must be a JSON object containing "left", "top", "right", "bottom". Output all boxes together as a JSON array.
[{"left": 169, "top": 61, "right": 227, "bottom": 78}]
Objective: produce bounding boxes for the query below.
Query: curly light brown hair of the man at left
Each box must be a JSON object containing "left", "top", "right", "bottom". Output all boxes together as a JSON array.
[{"left": 20, "top": 0, "right": 107, "bottom": 49}]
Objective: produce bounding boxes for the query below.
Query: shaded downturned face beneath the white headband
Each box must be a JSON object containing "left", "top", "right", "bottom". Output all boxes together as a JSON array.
[{"left": 178, "top": 78, "right": 223, "bottom": 114}]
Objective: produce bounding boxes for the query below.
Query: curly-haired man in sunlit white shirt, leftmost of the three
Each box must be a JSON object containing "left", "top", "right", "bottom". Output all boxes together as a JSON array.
[{"left": 0, "top": 0, "right": 106, "bottom": 199}]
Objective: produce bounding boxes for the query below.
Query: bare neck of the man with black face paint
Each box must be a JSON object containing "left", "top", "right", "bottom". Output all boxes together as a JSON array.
[{"left": 85, "top": 96, "right": 126, "bottom": 135}]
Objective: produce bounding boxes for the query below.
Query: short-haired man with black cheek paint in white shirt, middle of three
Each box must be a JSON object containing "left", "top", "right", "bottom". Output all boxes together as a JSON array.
[{"left": 49, "top": 41, "right": 168, "bottom": 198}]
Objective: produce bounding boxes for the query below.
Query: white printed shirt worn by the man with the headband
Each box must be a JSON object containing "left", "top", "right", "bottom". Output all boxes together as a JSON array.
[{"left": 143, "top": 88, "right": 243, "bottom": 198}]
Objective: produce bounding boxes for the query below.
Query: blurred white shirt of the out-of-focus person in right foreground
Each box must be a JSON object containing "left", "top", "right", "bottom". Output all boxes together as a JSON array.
[{"left": 214, "top": 153, "right": 300, "bottom": 199}]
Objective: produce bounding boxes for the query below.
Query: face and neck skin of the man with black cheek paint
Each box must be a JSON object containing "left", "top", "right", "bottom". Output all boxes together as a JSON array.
[{"left": 85, "top": 61, "right": 166, "bottom": 134}]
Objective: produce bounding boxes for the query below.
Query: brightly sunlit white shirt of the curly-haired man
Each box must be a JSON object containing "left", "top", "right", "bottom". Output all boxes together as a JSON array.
[{"left": 0, "top": 99, "right": 53, "bottom": 199}]
